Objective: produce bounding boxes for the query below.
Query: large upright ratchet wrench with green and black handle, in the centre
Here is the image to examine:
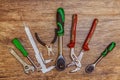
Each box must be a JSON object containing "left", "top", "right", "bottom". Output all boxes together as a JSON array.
[{"left": 56, "top": 8, "right": 66, "bottom": 71}]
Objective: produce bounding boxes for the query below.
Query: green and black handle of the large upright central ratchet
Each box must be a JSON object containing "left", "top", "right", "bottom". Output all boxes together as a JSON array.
[{"left": 57, "top": 8, "right": 65, "bottom": 36}]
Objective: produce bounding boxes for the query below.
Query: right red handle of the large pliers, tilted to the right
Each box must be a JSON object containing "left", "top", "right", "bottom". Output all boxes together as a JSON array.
[{"left": 82, "top": 18, "right": 98, "bottom": 51}]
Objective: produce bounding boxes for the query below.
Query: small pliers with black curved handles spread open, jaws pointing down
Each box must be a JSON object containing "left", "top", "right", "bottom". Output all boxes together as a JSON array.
[{"left": 35, "top": 29, "right": 57, "bottom": 56}]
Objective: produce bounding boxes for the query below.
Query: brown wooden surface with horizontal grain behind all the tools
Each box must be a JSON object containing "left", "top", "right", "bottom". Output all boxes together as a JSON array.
[{"left": 0, "top": 0, "right": 120, "bottom": 80}]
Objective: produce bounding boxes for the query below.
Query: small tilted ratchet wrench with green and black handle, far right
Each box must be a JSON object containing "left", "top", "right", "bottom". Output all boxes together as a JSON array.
[{"left": 85, "top": 42, "right": 116, "bottom": 73}]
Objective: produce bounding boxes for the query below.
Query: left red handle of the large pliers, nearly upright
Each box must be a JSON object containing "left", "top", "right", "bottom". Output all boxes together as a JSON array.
[{"left": 68, "top": 14, "right": 77, "bottom": 48}]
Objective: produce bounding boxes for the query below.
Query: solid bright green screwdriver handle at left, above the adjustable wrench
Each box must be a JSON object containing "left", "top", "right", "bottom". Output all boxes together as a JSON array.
[{"left": 12, "top": 38, "right": 28, "bottom": 57}]
